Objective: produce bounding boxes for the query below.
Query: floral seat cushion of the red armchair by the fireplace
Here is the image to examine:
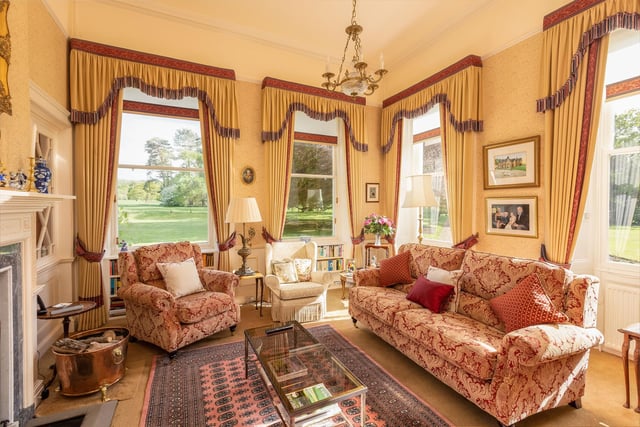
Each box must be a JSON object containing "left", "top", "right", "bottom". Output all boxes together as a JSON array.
[{"left": 175, "top": 291, "right": 233, "bottom": 323}]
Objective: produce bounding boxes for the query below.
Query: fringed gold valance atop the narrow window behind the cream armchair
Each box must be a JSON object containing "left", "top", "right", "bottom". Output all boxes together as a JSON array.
[{"left": 262, "top": 77, "right": 368, "bottom": 151}]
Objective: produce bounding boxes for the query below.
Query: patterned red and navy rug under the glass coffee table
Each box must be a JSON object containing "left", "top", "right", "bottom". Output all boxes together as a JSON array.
[{"left": 140, "top": 325, "right": 450, "bottom": 427}]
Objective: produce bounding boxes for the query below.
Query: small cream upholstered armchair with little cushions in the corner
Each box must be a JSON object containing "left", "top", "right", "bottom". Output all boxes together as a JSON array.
[{"left": 265, "top": 241, "right": 331, "bottom": 322}]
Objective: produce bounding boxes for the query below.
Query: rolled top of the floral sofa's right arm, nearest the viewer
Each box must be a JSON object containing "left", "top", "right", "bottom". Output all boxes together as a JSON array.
[{"left": 501, "top": 323, "right": 604, "bottom": 366}]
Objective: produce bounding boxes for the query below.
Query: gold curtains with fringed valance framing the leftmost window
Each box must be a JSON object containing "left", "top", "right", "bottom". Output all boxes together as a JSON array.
[{"left": 69, "top": 39, "right": 240, "bottom": 329}]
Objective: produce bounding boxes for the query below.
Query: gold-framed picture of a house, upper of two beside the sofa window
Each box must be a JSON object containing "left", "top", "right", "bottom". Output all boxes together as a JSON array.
[{"left": 483, "top": 135, "right": 540, "bottom": 190}]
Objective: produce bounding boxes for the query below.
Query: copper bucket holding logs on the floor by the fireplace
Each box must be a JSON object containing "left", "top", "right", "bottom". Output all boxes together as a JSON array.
[{"left": 52, "top": 328, "right": 129, "bottom": 400}]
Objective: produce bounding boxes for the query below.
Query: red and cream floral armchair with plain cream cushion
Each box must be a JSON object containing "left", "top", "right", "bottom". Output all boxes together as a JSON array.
[{"left": 118, "top": 242, "right": 240, "bottom": 356}]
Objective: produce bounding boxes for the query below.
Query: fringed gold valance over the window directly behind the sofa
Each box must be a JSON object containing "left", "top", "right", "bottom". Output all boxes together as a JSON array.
[{"left": 381, "top": 55, "right": 483, "bottom": 153}]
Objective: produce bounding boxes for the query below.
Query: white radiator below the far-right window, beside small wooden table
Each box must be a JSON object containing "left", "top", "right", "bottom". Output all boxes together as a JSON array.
[{"left": 604, "top": 284, "right": 640, "bottom": 354}]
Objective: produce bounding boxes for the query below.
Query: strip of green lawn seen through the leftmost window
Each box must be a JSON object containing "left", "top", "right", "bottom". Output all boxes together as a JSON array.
[{"left": 118, "top": 200, "right": 208, "bottom": 245}]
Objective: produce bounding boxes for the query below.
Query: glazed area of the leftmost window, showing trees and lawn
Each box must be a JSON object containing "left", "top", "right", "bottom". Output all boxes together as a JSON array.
[{"left": 117, "top": 114, "right": 208, "bottom": 245}]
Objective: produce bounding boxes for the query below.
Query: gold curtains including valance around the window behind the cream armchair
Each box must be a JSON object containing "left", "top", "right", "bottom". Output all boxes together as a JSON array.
[{"left": 262, "top": 78, "right": 368, "bottom": 239}]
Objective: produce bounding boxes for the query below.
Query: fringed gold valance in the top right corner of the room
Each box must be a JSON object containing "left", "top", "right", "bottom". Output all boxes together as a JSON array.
[{"left": 536, "top": 0, "right": 640, "bottom": 112}]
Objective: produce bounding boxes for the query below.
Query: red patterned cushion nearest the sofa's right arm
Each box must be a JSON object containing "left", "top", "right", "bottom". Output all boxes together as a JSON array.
[{"left": 489, "top": 274, "right": 569, "bottom": 332}]
